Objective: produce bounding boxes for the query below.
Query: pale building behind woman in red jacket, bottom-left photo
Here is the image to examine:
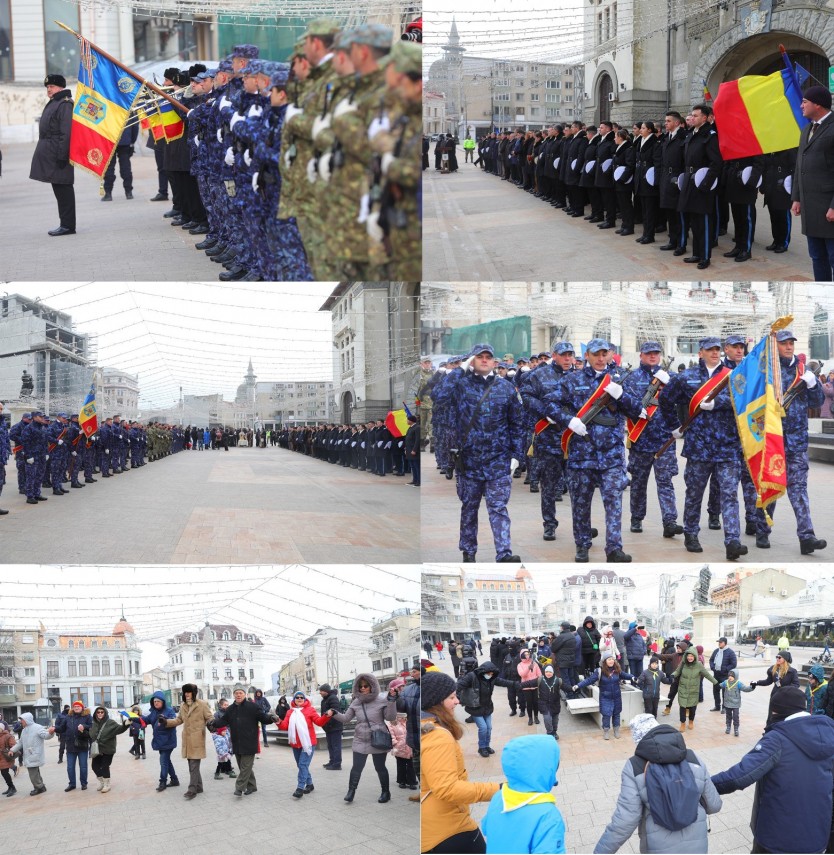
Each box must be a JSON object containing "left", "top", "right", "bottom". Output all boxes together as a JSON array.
[{"left": 272, "top": 626, "right": 371, "bottom": 696}]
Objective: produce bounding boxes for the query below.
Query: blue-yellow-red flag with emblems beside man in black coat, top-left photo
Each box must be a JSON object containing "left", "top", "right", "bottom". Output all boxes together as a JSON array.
[{"left": 70, "top": 39, "right": 142, "bottom": 178}]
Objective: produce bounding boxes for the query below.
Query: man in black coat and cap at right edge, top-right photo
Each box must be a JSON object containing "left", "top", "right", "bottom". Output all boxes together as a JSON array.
[{"left": 791, "top": 86, "right": 834, "bottom": 282}]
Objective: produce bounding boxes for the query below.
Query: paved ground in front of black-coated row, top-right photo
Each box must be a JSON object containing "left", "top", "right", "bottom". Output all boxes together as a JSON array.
[{"left": 423, "top": 155, "right": 813, "bottom": 282}]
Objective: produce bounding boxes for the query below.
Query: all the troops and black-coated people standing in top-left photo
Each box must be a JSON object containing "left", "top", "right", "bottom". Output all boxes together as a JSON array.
[{"left": 31, "top": 18, "right": 422, "bottom": 281}]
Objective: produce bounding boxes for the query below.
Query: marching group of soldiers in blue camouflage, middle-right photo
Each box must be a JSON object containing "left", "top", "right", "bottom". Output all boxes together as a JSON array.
[{"left": 423, "top": 329, "right": 826, "bottom": 563}]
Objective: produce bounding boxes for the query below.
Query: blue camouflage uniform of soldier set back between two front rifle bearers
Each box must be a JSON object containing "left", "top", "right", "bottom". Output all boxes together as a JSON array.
[{"left": 623, "top": 352, "right": 680, "bottom": 537}]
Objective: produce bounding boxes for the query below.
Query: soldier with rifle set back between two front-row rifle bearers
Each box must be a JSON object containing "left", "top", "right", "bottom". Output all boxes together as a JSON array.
[{"left": 623, "top": 341, "right": 683, "bottom": 537}]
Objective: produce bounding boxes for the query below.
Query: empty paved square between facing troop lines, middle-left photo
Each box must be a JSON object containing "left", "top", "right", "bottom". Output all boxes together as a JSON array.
[{"left": 0, "top": 447, "right": 420, "bottom": 564}]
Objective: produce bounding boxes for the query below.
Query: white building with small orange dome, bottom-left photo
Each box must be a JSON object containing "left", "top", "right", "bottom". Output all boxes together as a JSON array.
[{"left": 39, "top": 615, "right": 142, "bottom": 711}]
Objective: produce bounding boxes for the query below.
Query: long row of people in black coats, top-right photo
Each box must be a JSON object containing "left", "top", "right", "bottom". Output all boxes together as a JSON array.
[{"left": 458, "top": 86, "right": 834, "bottom": 281}]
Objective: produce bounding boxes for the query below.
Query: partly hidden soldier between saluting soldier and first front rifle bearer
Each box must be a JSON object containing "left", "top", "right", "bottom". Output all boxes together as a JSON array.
[{"left": 522, "top": 341, "right": 574, "bottom": 540}]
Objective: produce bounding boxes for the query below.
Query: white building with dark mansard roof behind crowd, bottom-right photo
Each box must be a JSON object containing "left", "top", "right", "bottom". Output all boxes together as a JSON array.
[{"left": 542, "top": 570, "right": 638, "bottom": 630}]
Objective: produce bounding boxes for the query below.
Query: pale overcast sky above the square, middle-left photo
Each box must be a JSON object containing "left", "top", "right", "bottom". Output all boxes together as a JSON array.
[{"left": 5, "top": 282, "right": 337, "bottom": 408}]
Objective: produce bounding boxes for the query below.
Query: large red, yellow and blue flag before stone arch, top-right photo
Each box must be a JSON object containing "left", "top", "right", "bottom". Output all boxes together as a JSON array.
[{"left": 713, "top": 48, "right": 808, "bottom": 160}]
